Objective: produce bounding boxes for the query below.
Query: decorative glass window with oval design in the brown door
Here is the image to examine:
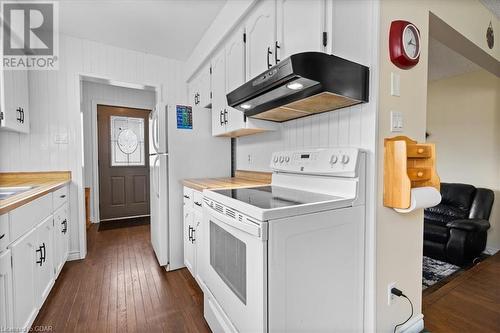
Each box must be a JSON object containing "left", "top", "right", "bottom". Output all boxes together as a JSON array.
[{"left": 110, "top": 116, "right": 145, "bottom": 166}]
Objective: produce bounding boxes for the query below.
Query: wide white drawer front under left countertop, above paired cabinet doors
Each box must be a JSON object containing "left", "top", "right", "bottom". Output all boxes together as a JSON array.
[{"left": 9, "top": 193, "right": 53, "bottom": 241}]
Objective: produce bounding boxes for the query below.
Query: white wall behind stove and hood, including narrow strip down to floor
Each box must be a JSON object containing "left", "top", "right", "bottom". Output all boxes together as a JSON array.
[{"left": 236, "top": 0, "right": 379, "bottom": 330}]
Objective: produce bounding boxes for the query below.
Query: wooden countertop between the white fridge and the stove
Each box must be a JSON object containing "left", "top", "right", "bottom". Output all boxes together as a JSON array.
[{"left": 182, "top": 170, "right": 271, "bottom": 191}]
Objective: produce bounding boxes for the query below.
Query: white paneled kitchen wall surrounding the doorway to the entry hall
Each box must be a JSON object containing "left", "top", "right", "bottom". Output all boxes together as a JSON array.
[{"left": 0, "top": 35, "right": 186, "bottom": 258}]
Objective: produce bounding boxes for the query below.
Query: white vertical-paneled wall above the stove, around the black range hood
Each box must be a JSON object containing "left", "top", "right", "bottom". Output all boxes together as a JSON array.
[{"left": 236, "top": 0, "right": 378, "bottom": 171}]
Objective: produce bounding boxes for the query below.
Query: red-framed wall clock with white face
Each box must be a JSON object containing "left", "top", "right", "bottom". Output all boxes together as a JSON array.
[{"left": 389, "top": 20, "right": 420, "bottom": 69}]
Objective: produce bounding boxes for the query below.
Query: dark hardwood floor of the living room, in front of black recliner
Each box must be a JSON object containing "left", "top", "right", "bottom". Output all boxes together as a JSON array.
[{"left": 422, "top": 253, "right": 500, "bottom": 333}]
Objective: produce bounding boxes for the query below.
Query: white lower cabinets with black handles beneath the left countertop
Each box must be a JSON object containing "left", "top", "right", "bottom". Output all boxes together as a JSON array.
[{"left": 0, "top": 184, "right": 69, "bottom": 331}]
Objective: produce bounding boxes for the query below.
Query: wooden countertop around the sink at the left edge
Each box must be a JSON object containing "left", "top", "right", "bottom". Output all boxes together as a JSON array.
[{"left": 0, "top": 171, "right": 71, "bottom": 215}]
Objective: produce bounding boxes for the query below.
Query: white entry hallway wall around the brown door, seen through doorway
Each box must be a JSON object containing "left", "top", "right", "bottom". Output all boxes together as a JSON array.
[{"left": 81, "top": 81, "right": 155, "bottom": 223}]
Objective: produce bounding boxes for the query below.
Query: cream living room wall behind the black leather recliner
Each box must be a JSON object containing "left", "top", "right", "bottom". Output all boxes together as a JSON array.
[{"left": 427, "top": 70, "right": 500, "bottom": 250}]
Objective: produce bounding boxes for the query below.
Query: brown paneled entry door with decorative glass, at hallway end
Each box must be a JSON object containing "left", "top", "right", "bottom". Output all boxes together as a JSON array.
[{"left": 97, "top": 105, "right": 150, "bottom": 221}]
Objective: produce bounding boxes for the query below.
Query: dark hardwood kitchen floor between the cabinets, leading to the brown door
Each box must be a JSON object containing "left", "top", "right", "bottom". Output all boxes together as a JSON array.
[{"left": 33, "top": 225, "right": 210, "bottom": 332}]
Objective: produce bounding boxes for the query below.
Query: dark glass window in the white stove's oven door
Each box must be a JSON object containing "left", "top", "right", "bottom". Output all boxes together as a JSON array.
[{"left": 210, "top": 221, "right": 247, "bottom": 304}]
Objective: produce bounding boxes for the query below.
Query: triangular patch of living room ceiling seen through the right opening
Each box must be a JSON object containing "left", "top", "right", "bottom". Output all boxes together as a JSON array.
[{"left": 428, "top": 37, "right": 481, "bottom": 81}]
